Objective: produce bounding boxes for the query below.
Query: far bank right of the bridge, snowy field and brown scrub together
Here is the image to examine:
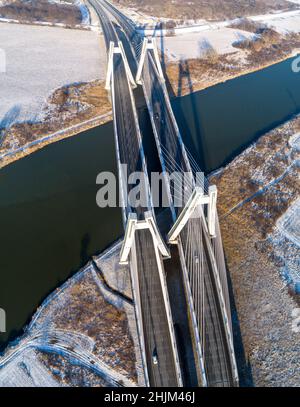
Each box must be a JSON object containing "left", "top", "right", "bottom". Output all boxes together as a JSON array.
[{"left": 163, "top": 11, "right": 300, "bottom": 95}]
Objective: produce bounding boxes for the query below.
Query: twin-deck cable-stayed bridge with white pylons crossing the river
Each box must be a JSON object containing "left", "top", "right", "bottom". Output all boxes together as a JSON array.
[{"left": 90, "top": 0, "right": 238, "bottom": 386}]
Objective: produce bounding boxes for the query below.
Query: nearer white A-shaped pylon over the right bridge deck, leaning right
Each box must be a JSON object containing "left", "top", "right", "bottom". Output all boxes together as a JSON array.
[{"left": 168, "top": 185, "right": 217, "bottom": 244}]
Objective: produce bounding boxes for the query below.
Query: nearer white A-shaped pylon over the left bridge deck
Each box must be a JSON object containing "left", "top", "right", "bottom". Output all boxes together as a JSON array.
[{"left": 120, "top": 211, "right": 170, "bottom": 264}]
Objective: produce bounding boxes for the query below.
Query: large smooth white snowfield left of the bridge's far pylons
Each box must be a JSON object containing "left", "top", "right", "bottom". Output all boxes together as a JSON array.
[{"left": 0, "top": 23, "right": 106, "bottom": 127}]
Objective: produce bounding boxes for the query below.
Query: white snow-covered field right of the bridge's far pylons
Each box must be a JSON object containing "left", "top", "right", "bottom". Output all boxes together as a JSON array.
[{"left": 157, "top": 28, "right": 254, "bottom": 61}]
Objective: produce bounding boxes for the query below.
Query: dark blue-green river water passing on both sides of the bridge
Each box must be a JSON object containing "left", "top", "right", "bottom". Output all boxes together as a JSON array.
[{"left": 0, "top": 56, "right": 300, "bottom": 347}]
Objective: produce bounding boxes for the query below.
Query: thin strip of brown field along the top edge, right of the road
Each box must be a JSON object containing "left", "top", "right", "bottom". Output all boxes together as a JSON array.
[{"left": 113, "top": 0, "right": 297, "bottom": 20}]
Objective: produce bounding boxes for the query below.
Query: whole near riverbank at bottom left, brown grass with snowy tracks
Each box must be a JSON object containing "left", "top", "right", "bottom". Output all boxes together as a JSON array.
[{"left": 0, "top": 242, "right": 144, "bottom": 387}]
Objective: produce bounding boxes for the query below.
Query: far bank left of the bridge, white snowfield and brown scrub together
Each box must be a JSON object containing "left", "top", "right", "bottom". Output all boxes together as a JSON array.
[{"left": 0, "top": 23, "right": 111, "bottom": 166}]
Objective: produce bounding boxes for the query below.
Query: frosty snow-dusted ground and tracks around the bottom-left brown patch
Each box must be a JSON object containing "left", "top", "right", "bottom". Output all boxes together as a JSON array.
[{"left": 0, "top": 256, "right": 144, "bottom": 387}]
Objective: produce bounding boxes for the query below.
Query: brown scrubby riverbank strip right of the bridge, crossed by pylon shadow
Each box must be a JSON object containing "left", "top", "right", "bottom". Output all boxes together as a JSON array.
[{"left": 166, "top": 26, "right": 300, "bottom": 96}]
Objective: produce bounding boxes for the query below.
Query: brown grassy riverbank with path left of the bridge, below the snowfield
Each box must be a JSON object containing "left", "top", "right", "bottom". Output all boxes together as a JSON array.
[{"left": 0, "top": 81, "right": 112, "bottom": 168}]
